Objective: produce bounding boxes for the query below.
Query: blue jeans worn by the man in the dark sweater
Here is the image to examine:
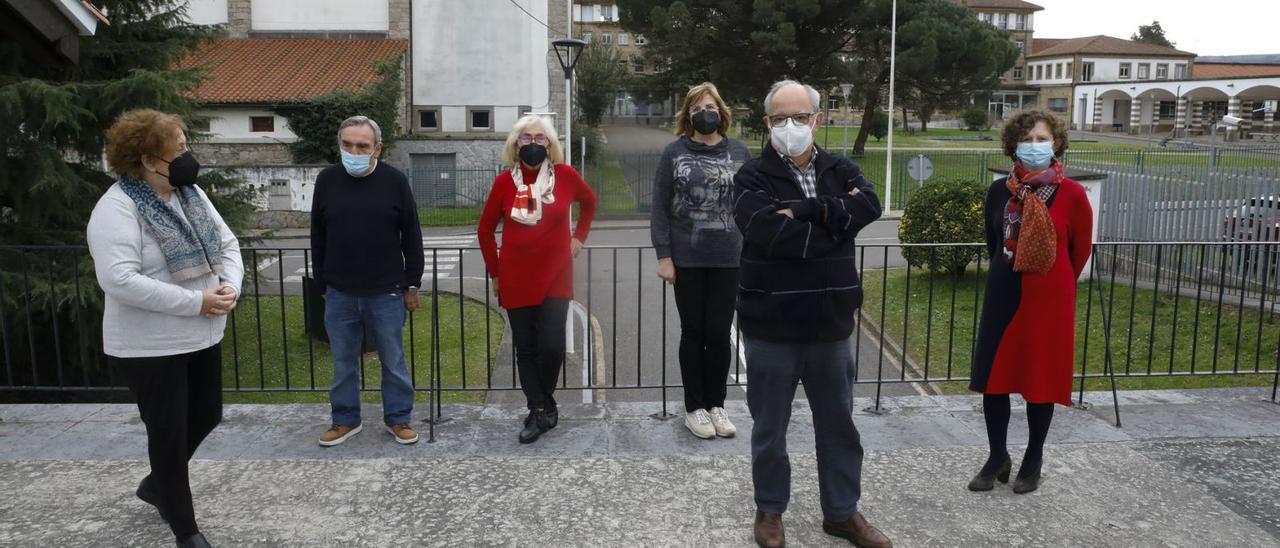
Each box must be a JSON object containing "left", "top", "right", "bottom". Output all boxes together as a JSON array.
[{"left": 324, "top": 287, "right": 413, "bottom": 426}]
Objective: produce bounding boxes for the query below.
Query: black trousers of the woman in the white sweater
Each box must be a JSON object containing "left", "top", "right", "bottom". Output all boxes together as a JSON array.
[{"left": 106, "top": 344, "right": 223, "bottom": 540}]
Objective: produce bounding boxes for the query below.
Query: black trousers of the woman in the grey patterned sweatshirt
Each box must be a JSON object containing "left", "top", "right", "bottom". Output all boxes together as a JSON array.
[{"left": 675, "top": 266, "right": 739, "bottom": 412}]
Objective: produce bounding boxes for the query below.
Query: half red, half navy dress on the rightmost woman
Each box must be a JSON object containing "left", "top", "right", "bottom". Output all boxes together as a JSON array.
[{"left": 969, "top": 179, "right": 1093, "bottom": 405}]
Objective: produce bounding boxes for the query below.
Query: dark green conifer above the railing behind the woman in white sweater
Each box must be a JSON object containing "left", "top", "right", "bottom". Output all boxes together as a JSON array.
[{"left": 0, "top": 0, "right": 218, "bottom": 243}]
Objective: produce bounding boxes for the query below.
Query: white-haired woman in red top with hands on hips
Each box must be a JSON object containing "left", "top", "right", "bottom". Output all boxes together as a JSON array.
[{"left": 477, "top": 114, "right": 595, "bottom": 443}]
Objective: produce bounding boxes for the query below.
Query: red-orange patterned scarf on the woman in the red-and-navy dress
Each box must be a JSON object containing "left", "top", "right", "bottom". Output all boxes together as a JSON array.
[{"left": 1005, "top": 160, "right": 1064, "bottom": 274}]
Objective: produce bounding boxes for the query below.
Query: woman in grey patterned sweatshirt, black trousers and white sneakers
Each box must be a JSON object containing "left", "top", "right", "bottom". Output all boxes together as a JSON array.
[{"left": 649, "top": 82, "right": 750, "bottom": 439}]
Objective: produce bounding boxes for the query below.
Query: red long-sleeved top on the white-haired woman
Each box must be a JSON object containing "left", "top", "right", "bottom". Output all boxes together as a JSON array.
[{"left": 477, "top": 164, "right": 595, "bottom": 309}]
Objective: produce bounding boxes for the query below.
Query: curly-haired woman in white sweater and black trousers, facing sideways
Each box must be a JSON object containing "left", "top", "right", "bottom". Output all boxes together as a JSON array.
[{"left": 88, "top": 110, "right": 244, "bottom": 547}]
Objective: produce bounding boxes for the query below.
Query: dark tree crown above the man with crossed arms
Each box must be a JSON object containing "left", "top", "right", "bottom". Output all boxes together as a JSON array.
[{"left": 617, "top": 0, "right": 867, "bottom": 125}]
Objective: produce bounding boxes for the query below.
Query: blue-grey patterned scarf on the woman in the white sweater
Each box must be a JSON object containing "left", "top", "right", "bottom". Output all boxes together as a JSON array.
[{"left": 115, "top": 175, "right": 223, "bottom": 282}]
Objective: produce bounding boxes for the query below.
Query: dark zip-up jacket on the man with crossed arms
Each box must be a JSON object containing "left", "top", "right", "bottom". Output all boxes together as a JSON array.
[{"left": 733, "top": 145, "right": 881, "bottom": 343}]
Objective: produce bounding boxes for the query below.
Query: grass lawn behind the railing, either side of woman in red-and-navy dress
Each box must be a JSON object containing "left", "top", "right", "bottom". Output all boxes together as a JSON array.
[{"left": 863, "top": 268, "right": 1280, "bottom": 393}]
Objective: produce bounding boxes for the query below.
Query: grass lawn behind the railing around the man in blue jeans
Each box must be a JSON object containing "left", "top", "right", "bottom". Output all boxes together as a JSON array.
[{"left": 223, "top": 293, "right": 504, "bottom": 403}]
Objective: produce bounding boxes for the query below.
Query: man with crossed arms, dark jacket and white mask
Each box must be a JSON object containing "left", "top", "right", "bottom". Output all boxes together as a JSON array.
[{"left": 733, "top": 81, "right": 892, "bottom": 548}]
